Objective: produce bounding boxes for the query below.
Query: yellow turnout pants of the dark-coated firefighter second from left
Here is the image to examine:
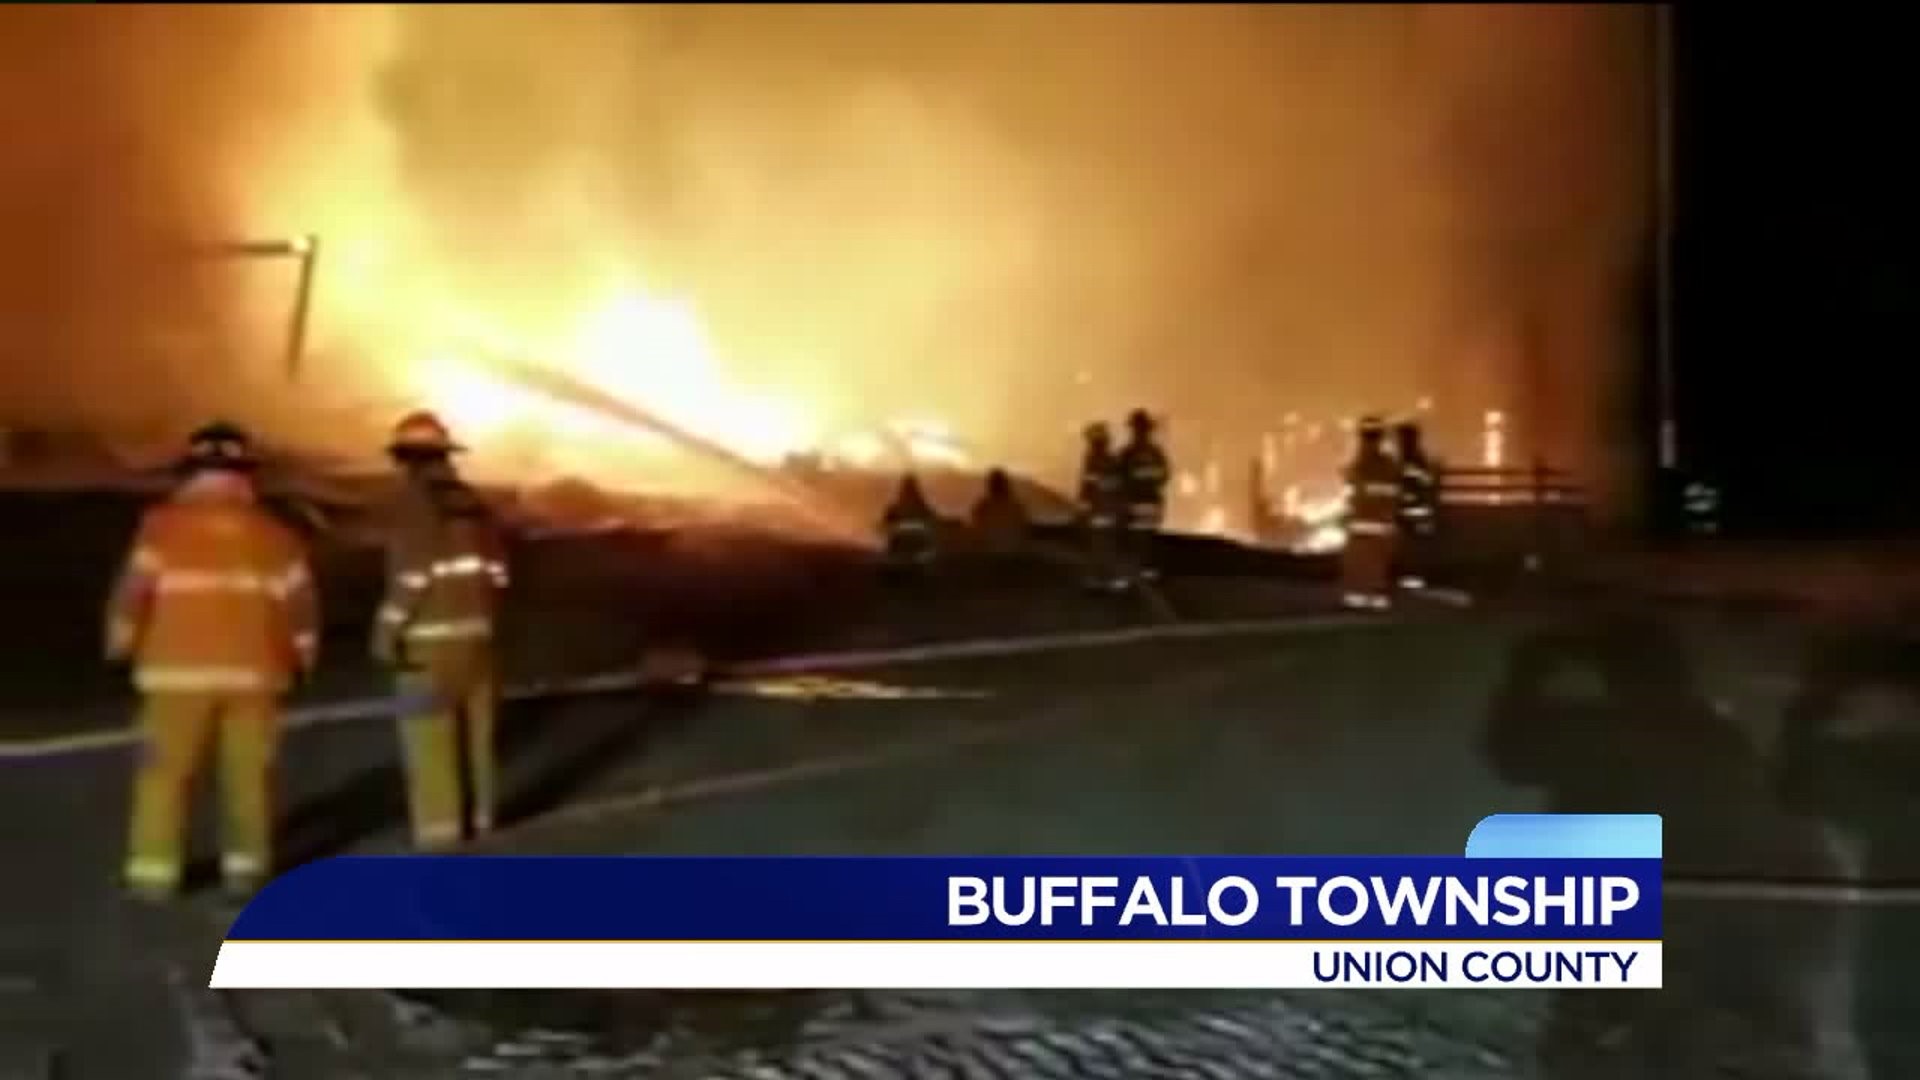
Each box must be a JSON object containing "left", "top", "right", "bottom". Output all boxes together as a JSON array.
[{"left": 397, "top": 646, "right": 499, "bottom": 849}]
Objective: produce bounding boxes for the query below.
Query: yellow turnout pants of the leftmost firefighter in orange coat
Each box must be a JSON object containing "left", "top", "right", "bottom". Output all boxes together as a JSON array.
[{"left": 127, "top": 692, "right": 280, "bottom": 890}]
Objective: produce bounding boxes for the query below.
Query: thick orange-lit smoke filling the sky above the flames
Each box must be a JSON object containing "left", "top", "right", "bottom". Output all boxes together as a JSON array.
[{"left": 0, "top": 4, "right": 1647, "bottom": 503}]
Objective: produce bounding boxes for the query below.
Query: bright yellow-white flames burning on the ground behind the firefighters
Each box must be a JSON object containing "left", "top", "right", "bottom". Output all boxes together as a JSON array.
[{"left": 243, "top": 195, "right": 1397, "bottom": 552}]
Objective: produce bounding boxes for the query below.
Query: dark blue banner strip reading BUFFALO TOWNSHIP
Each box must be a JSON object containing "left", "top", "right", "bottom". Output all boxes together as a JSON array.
[{"left": 227, "top": 853, "right": 1661, "bottom": 942}]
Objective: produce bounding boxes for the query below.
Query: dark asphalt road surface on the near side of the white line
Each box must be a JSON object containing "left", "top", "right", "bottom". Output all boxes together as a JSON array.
[{"left": 11, "top": 595, "right": 1920, "bottom": 1080}]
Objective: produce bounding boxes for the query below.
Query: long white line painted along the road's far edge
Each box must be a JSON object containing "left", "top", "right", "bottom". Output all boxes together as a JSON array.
[{"left": 0, "top": 615, "right": 1398, "bottom": 765}]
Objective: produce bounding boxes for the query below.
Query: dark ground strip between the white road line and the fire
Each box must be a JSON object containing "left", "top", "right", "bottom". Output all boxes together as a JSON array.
[{"left": 0, "top": 486, "right": 1327, "bottom": 742}]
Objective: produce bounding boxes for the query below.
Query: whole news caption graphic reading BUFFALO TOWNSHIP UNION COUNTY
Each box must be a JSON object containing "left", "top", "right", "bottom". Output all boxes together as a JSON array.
[{"left": 211, "top": 815, "right": 1661, "bottom": 990}]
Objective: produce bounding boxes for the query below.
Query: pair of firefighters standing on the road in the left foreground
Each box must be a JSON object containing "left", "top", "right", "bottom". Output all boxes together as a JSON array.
[{"left": 106, "top": 413, "right": 507, "bottom": 899}]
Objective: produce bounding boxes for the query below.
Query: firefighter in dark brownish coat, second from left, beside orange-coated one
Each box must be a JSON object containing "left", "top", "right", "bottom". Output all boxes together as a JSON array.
[{"left": 372, "top": 411, "right": 507, "bottom": 849}]
